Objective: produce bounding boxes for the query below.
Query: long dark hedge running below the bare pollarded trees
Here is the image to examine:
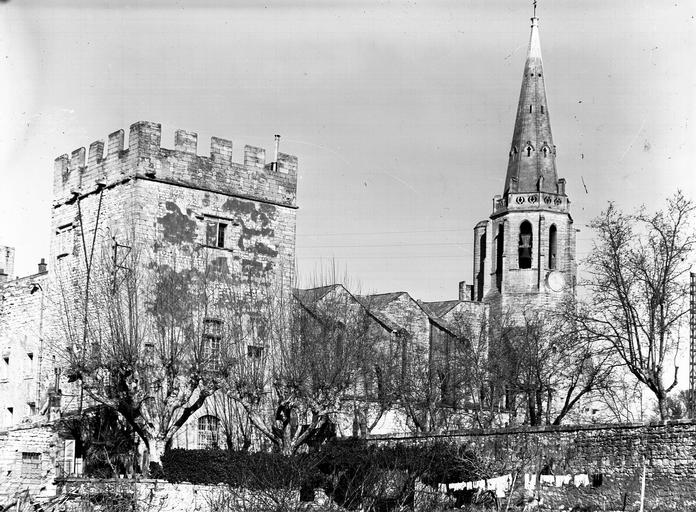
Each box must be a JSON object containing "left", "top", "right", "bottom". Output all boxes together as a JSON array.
[{"left": 162, "top": 440, "right": 480, "bottom": 489}]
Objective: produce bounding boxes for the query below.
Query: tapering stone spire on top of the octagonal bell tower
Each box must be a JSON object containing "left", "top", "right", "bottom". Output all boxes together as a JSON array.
[{"left": 504, "top": 11, "right": 563, "bottom": 196}]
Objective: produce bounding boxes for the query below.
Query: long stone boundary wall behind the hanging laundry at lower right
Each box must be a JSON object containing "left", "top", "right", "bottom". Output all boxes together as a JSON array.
[{"left": 370, "top": 420, "right": 696, "bottom": 510}]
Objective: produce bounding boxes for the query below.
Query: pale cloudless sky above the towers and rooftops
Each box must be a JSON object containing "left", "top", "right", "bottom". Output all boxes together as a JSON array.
[{"left": 0, "top": 0, "right": 696, "bottom": 300}]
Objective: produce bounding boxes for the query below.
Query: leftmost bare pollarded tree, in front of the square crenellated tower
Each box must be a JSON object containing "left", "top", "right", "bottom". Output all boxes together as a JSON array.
[{"left": 58, "top": 247, "right": 230, "bottom": 472}]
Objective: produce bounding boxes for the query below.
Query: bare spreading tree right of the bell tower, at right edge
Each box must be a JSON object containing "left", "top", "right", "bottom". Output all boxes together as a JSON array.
[{"left": 577, "top": 192, "right": 696, "bottom": 419}]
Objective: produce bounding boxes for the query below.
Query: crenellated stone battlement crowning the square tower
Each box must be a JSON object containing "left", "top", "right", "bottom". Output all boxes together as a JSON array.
[{"left": 53, "top": 121, "right": 297, "bottom": 206}]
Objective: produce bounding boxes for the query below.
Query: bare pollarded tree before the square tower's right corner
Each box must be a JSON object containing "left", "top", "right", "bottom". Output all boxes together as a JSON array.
[{"left": 221, "top": 285, "right": 375, "bottom": 454}]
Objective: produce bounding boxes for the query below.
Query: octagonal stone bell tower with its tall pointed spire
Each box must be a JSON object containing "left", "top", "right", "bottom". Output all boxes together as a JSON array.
[{"left": 472, "top": 16, "right": 576, "bottom": 314}]
